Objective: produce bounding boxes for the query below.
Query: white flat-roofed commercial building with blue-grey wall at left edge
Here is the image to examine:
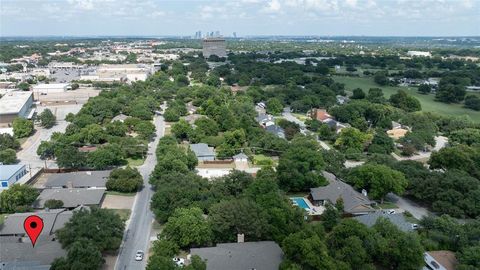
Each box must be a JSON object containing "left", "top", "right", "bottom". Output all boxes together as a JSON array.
[{"left": 0, "top": 91, "right": 33, "bottom": 125}]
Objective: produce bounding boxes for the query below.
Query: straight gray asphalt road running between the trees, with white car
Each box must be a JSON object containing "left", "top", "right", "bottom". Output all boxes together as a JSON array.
[{"left": 115, "top": 116, "right": 165, "bottom": 270}]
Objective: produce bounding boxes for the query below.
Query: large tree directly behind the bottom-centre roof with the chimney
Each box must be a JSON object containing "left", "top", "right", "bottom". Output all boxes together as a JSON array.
[{"left": 208, "top": 199, "right": 267, "bottom": 242}]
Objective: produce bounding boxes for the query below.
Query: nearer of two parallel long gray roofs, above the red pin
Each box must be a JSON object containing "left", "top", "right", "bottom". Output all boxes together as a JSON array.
[{"left": 33, "top": 188, "right": 105, "bottom": 208}]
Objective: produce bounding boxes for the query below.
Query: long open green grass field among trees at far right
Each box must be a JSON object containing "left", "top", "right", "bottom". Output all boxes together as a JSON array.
[{"left": 333, "top": 76, "right": 480, "bottom": 123}]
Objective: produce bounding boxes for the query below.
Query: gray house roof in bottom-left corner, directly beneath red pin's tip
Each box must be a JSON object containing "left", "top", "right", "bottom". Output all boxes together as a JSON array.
[{"left": 0, "top": 236, "right": 66, "bottom": 270}]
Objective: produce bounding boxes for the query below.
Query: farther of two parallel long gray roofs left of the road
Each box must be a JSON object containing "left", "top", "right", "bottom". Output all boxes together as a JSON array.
[{"left": 45, "top": 171, "right": 110, "bottom": 188}]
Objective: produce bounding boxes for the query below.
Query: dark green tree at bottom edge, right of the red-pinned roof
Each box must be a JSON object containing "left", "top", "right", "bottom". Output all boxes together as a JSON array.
[{"left": 50, "top": 239, "right": 105, "bottom": 270}]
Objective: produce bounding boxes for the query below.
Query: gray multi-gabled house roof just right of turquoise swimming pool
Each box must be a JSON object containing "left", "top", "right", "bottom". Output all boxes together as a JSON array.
[{"left": 310, "top": 172, "right": 375, "bottom": 214}]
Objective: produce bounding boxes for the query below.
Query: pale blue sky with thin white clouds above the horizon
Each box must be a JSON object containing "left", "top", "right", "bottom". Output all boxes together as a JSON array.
[{"left": 0, "top": 0, "right": 480, "bottom": 36}]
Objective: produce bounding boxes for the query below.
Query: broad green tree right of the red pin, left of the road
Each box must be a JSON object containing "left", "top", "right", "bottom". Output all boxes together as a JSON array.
[{"left": 56, "top": 208, "right": 125, "bottom": 252}]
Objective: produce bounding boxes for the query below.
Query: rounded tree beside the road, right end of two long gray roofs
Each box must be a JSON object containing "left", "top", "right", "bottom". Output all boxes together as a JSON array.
[{"left": 106, "top": 166, "right": 143, "bottom": 192}]
